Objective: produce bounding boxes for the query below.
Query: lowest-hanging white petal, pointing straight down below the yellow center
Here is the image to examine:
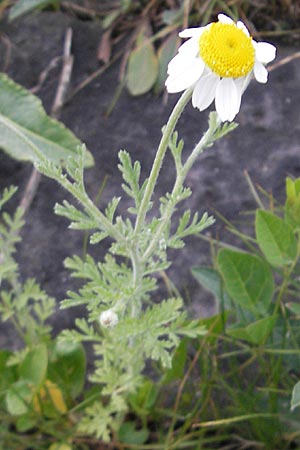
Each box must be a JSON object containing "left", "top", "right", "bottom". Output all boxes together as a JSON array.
[{"left": 215, "top": 78, "right": 242, "bottom": 122}]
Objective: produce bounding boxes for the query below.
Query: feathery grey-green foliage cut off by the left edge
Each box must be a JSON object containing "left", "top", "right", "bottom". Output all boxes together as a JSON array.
[{"left": 0, "top": 187, "right": 55, "bottom": 348}]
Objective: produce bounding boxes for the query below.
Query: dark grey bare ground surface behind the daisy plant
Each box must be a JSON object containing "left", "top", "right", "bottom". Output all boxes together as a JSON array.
[{"left": 0, "top": 8, "right": 300, "bottom": 347}]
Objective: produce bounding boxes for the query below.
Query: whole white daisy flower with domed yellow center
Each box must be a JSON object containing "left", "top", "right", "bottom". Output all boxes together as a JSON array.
[{"left": 166, "top": 14, "right": 276, "bottom": 122}]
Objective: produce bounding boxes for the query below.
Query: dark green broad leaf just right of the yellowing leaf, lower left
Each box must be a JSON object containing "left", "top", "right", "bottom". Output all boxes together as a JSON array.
[{"left": 49, "top": 340, "right": 86, "bottom": 398}]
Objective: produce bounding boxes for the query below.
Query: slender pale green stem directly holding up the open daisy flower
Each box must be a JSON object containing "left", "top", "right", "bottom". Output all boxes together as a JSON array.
[{"left": 134, "top": 89, "right": 193, "bottom": 236}]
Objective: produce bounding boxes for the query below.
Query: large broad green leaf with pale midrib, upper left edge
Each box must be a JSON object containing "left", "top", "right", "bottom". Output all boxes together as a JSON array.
[{"left": 0, "top": 74, "right": 93, "bottom": 166}]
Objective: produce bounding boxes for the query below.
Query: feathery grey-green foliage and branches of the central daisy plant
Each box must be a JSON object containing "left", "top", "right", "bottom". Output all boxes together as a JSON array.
[{"left": 36, "top": 114, "right": 234, "bottom": 440}]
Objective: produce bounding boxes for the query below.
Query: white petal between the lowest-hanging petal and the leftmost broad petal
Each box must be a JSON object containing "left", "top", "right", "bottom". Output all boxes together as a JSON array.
[{"left": 192, "top": 73, "right": 220, "bottom": 111}]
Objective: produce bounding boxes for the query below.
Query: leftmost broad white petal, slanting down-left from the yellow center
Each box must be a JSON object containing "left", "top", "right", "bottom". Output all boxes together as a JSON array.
[{"left": 165, "top": 58, "right": 204, "bottom": 93}]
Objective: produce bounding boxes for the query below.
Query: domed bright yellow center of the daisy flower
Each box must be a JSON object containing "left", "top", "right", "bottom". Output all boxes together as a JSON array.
[{"left": 199, "top": 22, "right": 255, "bottom": 78}]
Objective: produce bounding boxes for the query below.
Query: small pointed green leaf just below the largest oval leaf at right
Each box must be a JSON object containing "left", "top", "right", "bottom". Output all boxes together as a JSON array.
[{"left": 227, "top": 316, "right": 276, "bottom": 345}]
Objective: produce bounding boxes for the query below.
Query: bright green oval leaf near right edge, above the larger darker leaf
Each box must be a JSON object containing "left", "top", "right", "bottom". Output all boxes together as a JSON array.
[{"left": 255, "top": 210, "right": 297, "bottom": 266}]
